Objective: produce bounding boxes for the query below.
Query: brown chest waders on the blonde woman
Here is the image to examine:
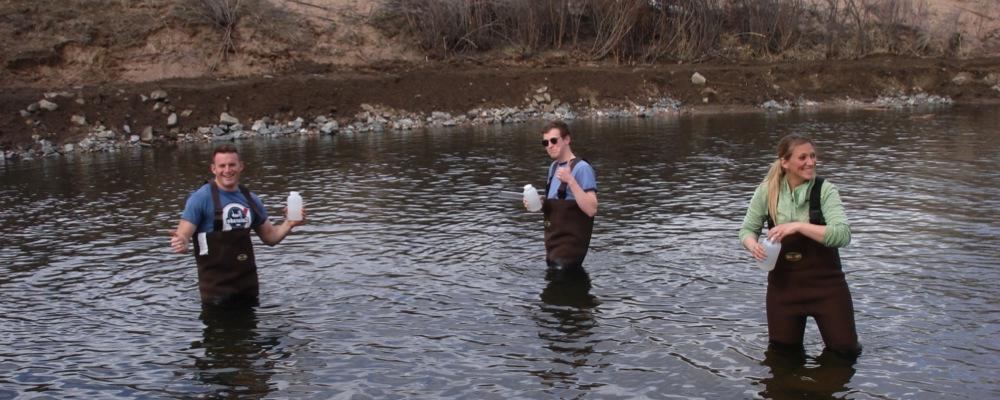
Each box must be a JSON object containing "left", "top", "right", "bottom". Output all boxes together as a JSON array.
[{"left": 767, "top": 177, "right": 861, "bottom": 356}]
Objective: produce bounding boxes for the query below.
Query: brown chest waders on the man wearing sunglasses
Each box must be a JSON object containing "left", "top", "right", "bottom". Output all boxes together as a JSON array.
[{"left": 542, "top": 159, "right": 594, "bottom": 279}]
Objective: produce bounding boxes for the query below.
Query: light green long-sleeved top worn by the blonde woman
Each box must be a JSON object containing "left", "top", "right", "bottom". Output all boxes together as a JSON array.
[{"left": 740, "top": 179, "right": 851, "bottom": 247}]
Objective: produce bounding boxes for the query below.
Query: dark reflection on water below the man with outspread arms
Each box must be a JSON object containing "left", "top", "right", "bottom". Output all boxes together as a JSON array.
[{"left": 191, "top": 305, "right": 278, "bottom": 398}]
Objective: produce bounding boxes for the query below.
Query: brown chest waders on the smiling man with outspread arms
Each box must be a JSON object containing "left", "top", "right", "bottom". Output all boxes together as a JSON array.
[{"left": 194, "top": 181, "right": 262, "bottom": 305}]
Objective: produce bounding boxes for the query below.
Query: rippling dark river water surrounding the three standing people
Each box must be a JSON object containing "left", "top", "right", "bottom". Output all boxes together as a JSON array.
[{"left": 0, "top": 108, "right": 1000, "bottom": 399}]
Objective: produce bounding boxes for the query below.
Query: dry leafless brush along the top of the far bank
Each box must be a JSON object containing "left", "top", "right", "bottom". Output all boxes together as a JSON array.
[{"left": 373, "top": 0, "right": 980, "bottom": 63}]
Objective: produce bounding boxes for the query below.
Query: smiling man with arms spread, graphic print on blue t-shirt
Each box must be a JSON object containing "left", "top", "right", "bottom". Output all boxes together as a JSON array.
[{"left": 170, "top": 146, "right": 305, "bottom": 305}]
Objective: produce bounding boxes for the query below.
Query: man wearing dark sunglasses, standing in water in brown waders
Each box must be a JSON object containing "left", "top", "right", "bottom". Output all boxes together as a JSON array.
[{"left": 542, "top": 121, "right": 597, "bottom": 281}]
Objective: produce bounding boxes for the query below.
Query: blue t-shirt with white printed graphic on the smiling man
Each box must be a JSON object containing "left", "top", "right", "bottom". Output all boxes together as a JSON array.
[{"left": 181, "top": 183, "right": 267, "bottom": 233}]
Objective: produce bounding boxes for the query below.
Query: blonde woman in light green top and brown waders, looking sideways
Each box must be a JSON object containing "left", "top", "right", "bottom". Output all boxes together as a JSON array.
[{"left": 740, "top": 134, "right": 861, "bottom": 357}]
